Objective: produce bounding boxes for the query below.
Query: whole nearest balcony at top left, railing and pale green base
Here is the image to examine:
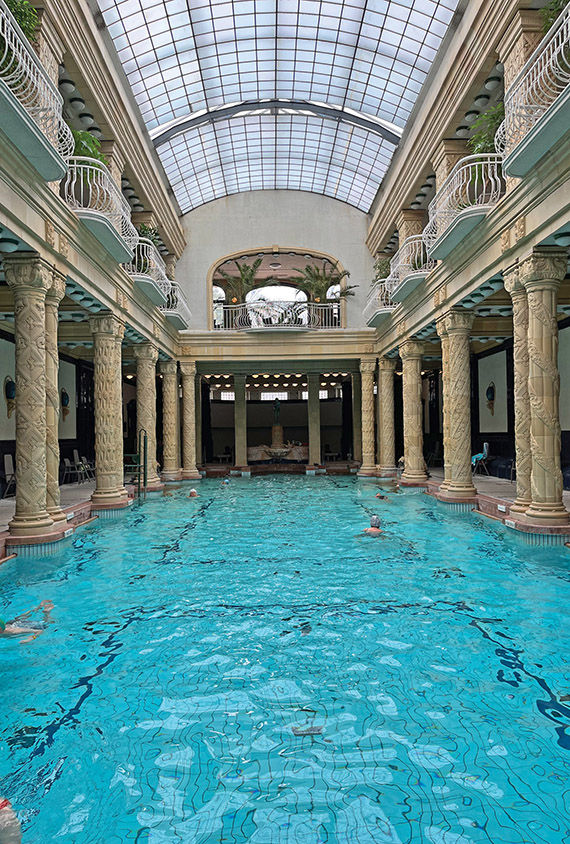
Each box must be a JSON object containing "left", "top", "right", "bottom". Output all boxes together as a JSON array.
[{"left": 0, "top": 0, "right": 73, "bottom": 182}]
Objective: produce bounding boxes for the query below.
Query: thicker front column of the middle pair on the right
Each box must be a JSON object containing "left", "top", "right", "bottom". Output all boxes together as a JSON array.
[{"left": 441, "top": 310, "right": 477, "bottom": 500}]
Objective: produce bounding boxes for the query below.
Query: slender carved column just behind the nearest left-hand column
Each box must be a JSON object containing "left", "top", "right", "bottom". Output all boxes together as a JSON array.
[{"left": 46, "top": 272, "right": 66, "bottom": 522}]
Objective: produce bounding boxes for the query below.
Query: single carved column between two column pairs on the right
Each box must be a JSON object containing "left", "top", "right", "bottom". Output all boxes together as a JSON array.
[{"left": 400, "top": 340, "right": 427, "bottom": 484}]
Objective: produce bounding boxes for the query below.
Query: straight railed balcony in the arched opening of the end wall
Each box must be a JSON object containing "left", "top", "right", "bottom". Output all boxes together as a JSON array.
[{"left": 214, "top": 301, "right": 341, "bottom": 332}]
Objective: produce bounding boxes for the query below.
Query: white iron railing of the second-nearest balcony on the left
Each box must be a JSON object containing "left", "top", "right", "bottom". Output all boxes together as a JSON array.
[{"left": 62, "top": 156, "right": 139, "bottom": 250}]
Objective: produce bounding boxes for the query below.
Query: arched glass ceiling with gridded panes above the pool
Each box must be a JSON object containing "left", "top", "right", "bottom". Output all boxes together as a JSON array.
[{"left": 95, "top": 0, "right": 457, "bottom": 212}]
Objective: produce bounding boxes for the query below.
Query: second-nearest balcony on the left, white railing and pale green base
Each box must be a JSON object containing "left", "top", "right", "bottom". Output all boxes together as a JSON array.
[{"left": 61, "top": 156, "right": 139, "bottom": 263}]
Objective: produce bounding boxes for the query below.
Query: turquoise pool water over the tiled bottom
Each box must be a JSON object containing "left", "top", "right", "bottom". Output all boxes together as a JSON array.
[{"left": 0, "top": 476, "right": 570, "bottom": 844}]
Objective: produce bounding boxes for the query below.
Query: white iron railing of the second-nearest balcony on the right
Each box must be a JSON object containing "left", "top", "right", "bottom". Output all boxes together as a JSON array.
[{"left": 423, "top": 153, "right": 505, "bottom": 251}]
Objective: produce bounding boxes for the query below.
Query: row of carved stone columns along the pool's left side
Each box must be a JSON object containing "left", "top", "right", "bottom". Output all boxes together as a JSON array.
[{"left": 3, "top": 255, "right": 200, "bottom": 541}]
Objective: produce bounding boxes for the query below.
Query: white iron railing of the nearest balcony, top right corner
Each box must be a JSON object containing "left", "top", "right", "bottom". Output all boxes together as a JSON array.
[{"left": 495, "top": 6, "right": 570, "bottom": 156}]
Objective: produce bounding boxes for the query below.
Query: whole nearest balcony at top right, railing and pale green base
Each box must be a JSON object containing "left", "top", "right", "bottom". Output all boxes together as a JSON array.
[{"left": 495, "top": 6, "right": 570, "bottom": 177}]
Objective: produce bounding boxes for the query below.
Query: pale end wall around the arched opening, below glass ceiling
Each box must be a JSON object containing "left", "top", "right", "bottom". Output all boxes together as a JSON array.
[{"left": 176, "top": 190, "right": 374, "bottom": 329}]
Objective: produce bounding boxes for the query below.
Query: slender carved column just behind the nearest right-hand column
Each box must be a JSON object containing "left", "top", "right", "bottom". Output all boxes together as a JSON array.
[{"left": 503, "top": 264, "right": 532, "bottom": 513}]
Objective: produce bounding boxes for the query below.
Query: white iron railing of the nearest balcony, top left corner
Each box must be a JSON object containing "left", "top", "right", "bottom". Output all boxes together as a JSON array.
[{"left": 0, "top": 0, "right": 73, "bottom": 158}]
